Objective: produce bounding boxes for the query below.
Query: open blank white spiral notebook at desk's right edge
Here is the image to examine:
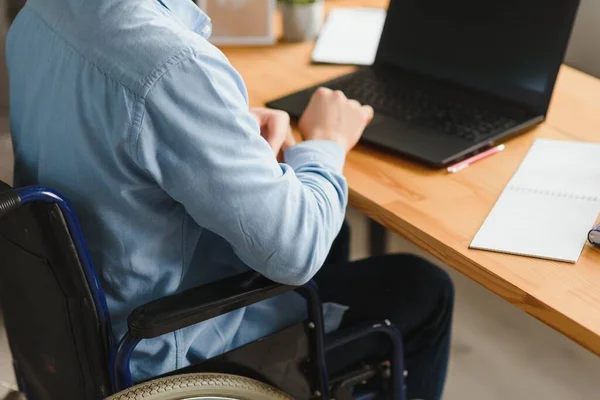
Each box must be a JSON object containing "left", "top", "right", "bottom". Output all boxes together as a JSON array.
[{"left": 470, "top": 139, "right": 600, "bottom": 263}]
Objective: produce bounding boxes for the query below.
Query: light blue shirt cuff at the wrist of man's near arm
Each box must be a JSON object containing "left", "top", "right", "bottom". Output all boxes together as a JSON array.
[{"left": 284, "top": 140, "right": 346, "bottom": 173}]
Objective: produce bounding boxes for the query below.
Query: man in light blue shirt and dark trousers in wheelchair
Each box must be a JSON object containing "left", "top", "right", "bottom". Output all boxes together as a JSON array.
[{"left": 7, "top": 0, "right": 453, "bottom": 400}]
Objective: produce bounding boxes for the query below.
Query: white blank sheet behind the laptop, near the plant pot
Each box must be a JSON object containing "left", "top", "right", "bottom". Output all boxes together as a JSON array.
[{"left": 312, "top": 8, "right": 386, "bottom": 65}]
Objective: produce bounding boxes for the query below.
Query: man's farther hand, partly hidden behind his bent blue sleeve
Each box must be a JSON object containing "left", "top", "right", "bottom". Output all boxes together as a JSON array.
[{"left": 250, "top": 107, "right": 296, "bottom": 160}]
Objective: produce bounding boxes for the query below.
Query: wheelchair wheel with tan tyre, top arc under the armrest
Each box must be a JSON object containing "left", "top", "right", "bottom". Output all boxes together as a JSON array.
[{"left": 106, "top": 373, "right": 293, "bottom": 400}]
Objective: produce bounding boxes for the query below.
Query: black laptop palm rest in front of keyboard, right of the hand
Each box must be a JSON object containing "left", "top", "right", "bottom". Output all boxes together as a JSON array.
[{"left": 363, "top": 114, "right": 474, "bottom": 166}]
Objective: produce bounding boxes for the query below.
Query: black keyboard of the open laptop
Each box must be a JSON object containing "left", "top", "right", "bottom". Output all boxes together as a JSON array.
[{"left": 331, "top": 69, "right": 524, "bottom": 142}]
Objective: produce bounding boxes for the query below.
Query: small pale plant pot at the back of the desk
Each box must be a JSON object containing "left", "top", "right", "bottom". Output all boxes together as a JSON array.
[{"left": 281, "top": 0, "right": 324, "bottom": 42}]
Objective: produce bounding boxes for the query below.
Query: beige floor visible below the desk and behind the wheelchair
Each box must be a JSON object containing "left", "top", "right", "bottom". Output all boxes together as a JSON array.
[{"left": 0, "top": 26, "right": 600, "bottom": 400}]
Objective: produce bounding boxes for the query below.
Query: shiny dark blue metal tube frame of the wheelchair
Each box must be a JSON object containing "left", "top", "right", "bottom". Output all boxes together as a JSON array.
[{"left": 13, "top": 187, "right": 405, "bottom": 400}]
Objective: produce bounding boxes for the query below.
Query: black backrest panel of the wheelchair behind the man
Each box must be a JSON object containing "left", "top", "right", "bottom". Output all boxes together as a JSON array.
[{"left": 0, "top": 182, "right": 113, "bottom": 400}]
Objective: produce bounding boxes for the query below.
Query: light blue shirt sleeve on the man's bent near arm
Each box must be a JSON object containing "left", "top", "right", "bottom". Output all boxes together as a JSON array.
[{"left": 133, "top": 50, "right": 348, "bottom": 285}]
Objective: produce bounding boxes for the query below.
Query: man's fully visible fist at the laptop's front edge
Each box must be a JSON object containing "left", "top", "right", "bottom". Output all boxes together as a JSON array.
[{"left": 298, "top": 87, "right": 373, "bottom": 152}]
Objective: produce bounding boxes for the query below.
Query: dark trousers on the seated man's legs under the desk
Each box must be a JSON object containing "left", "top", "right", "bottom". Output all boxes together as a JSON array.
[{"left": 315, "top": 222, "right": 454, "bottom": 400}]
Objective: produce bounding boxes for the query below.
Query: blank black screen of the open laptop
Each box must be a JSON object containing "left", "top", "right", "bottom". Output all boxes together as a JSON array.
[{"left": 376, "top": 0, "right": 579, "bottom": 113}]
